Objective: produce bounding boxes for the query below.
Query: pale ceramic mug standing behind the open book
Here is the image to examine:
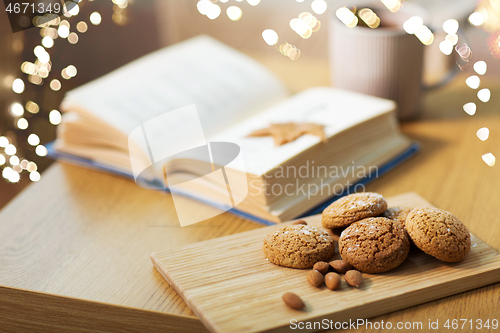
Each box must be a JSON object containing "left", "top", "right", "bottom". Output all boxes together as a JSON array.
[{"left": 329, "top": 2, "right": 440, "bottom": 119}]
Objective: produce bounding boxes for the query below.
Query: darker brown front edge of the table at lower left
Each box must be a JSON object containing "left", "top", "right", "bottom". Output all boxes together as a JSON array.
[{"left": 0, "top": 287, "right": 206, "bottom": 333}]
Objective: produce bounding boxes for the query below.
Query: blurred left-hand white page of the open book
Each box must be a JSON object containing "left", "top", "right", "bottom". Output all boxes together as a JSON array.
[{"left": 61, "top": 36, "right": 287, "bottom": 142}]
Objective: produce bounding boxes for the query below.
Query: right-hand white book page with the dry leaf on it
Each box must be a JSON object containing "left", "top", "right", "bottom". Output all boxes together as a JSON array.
[{"left": 211, "top": 87, "right": 396, "bottom": 176}]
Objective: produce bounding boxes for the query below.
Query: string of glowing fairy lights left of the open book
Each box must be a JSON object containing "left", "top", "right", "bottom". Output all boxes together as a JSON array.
[{"left": 0, "top": 0, "right": 129, "bottom": 183}]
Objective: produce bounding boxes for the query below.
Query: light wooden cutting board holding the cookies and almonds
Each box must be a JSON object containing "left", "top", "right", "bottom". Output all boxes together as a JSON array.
[{"left": 151, "top": 193, "right": 500, "bottom": 333}]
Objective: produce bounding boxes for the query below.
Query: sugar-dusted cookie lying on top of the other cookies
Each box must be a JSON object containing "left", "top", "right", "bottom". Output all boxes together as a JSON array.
[{"left": 321, "top": 192, "right": 387, "bottom": 229}]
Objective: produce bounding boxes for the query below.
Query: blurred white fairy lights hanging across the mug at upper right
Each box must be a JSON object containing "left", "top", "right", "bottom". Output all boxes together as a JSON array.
[{"left": 197, "top": 0, "right": 500, "bottom": 167}]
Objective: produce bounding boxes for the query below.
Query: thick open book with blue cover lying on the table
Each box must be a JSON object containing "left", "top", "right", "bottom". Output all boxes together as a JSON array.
[{"left": 49, "top": 36, "right": 416, "bottom": 223}]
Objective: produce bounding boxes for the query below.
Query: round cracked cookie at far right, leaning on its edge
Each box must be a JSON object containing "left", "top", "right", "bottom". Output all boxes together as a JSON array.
[{"left": 406, "top": 207, "right": 470, "bottom": 262}]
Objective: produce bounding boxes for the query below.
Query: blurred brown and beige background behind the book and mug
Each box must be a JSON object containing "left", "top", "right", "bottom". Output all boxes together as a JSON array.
[{"left": 0, "top": 0, "right": 494, "bottom": 207}]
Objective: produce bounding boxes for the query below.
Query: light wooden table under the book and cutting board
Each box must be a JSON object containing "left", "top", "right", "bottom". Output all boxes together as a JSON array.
[{"left": 0, "top": 56, "right": 500, "bottom": 332}]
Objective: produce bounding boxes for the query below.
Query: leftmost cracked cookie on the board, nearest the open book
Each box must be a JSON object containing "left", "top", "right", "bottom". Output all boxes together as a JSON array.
[{"left": 264, "top": 224, "right": 335, "bottom": 268}]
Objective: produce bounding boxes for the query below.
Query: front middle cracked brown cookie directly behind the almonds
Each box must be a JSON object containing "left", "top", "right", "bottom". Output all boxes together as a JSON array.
[{"left": 339, "top": 217, "right": 410, "bottom": 273}]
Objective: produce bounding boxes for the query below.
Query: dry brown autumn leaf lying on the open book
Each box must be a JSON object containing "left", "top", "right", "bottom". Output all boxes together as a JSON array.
[{"left": 248, "top": 123, "right": 327, "bottom": 146}]
